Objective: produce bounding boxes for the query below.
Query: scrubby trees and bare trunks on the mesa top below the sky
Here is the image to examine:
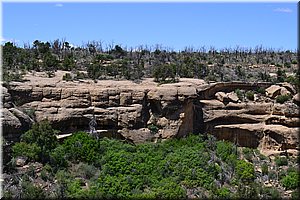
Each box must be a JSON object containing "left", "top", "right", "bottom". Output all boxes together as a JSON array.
[{"left": 2, "top": 39, "right": 299, "bottom": 90}]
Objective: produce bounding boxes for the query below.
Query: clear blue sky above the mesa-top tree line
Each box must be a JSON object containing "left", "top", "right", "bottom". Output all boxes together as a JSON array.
[{"left": 2, "top": 2, "right": 297, "bottom": 50}]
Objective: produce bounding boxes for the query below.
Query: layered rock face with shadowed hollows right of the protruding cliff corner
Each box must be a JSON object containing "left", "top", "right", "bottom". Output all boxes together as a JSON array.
[{"left": 200, "top": 92, "right": 300, "bottom": 151}]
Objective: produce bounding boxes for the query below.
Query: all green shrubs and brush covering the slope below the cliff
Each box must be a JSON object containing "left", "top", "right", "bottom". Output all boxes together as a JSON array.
[{"left": 4, "top": 122, "right": 299, "bottom": 199}]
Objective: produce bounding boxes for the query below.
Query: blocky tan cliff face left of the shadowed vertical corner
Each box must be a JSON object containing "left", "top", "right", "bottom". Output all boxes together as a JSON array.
[{"left": 4, "top": 77, "right": 203, "bottom": 143}]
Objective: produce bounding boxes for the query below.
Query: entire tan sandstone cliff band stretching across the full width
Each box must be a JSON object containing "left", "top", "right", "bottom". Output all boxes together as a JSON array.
[{"left": 2, "top": 72, "right": 299, "bottom": 155}]
